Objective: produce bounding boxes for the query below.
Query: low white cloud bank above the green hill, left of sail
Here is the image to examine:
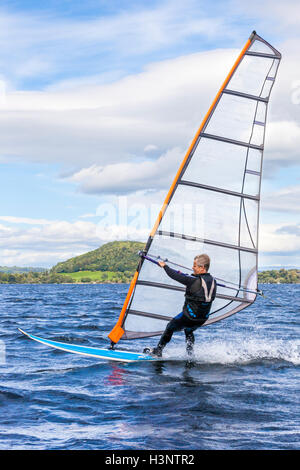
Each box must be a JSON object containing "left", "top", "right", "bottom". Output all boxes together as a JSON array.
[{"left": 0, "top": 218, "right": 147, "bottom": 267}]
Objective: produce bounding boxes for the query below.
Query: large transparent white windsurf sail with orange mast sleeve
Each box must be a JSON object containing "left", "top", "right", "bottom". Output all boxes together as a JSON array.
[{"left": 109, "top": 32, "right": 281, "bottom": 343}]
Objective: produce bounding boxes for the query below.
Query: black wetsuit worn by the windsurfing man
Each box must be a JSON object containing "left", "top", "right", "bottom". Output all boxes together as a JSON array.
[{"left": 158, "top": 265, "right": 216, "bottom": 350}]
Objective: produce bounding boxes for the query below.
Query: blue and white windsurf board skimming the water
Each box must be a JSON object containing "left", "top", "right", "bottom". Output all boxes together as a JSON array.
[{"left": 18, "top": 328, "right": 156, "bottom": 362}]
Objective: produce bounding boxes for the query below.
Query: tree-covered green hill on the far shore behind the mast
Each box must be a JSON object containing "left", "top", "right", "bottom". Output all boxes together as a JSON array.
[{"left": 51, "top": 241, "right": 145, "bottom": 274}]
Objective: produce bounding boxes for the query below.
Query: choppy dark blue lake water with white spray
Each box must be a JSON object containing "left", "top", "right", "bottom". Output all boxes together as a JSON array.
[{"left": 0, "top": 285, "right": 300, "bottom": 450}]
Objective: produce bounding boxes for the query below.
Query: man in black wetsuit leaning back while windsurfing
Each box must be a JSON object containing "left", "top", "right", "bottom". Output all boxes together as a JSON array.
[{"left": 144, "top": 254, "right": 217, "bottom": 357}]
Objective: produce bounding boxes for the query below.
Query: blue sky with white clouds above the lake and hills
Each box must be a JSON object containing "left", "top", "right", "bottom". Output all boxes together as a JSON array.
[{"left": 0, "top": 0, "right": 300, "bottom": 268}]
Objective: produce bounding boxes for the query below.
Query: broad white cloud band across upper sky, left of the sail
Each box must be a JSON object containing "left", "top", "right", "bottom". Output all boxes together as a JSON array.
[{"left": 0, "top": 50, "right": 237, "bottom": 168}]
